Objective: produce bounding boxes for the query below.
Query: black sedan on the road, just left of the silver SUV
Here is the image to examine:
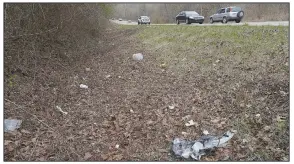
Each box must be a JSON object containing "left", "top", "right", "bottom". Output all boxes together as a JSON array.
[{"left": 176, "top": 11, "right": 204, "bottom": 24}]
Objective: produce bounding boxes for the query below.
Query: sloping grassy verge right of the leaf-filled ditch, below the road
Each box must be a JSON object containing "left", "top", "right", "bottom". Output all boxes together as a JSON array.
[{"left": 135, "top": 25, "right": 289, "bottom": 160}]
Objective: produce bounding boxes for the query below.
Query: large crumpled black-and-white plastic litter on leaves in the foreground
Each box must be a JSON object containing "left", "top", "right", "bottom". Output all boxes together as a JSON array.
[{"left": 172, "top": 131, "right": 234, "bottom": 160}]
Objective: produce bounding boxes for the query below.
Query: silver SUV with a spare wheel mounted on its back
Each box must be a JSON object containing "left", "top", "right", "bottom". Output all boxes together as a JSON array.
[{"left": 209, "top": 6, "right": 244, "bottom": 23}]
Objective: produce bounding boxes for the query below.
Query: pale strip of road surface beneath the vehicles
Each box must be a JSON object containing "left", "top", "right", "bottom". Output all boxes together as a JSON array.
[{"left": 110, "top": 20, "right": 289, "bottom": 26}]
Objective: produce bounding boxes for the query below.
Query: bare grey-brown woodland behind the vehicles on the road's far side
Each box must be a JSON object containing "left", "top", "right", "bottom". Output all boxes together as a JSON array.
[{"left": 114, "top": 3, "right": 289, "bottom": 23}]
